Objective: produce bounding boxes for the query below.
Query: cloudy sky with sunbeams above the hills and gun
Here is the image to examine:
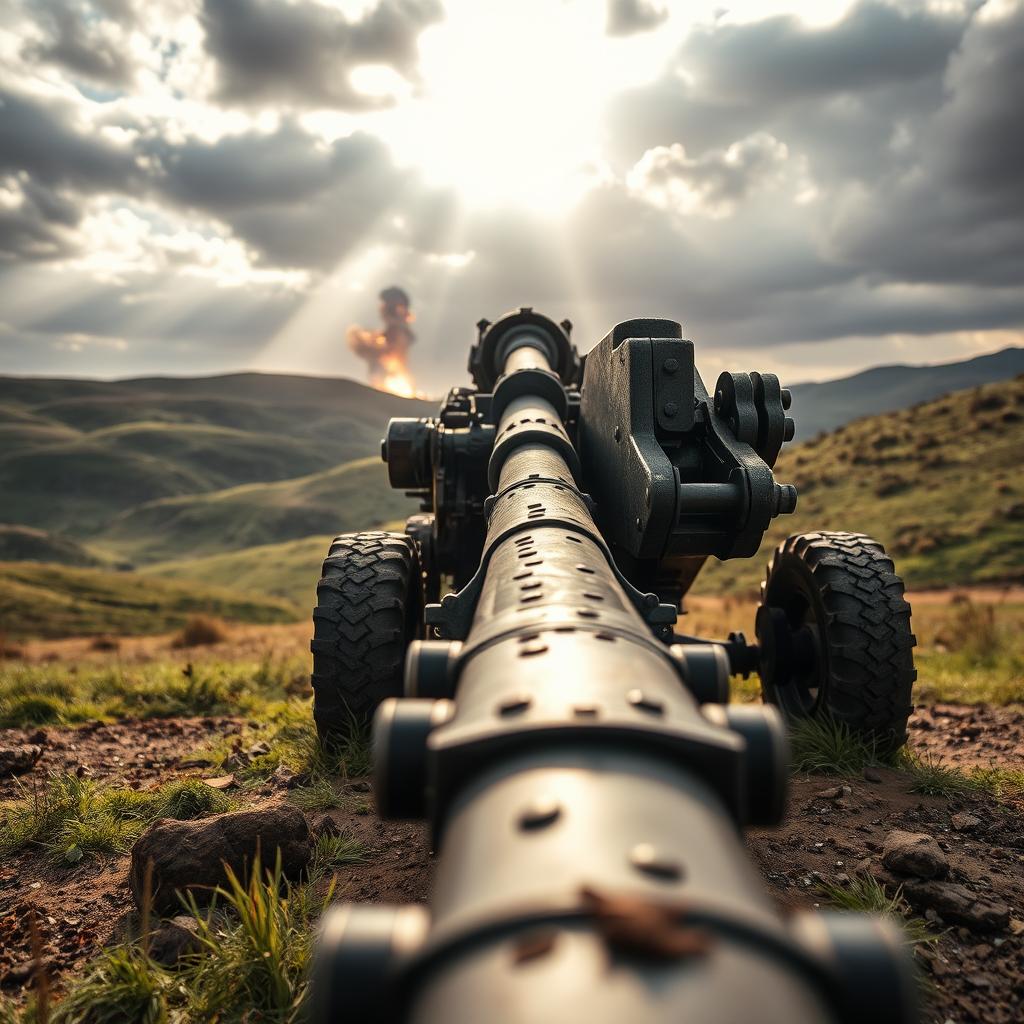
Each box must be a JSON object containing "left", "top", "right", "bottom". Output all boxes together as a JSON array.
[{"left": 0, "top": 0, "right": 1024, "bottom": 393}]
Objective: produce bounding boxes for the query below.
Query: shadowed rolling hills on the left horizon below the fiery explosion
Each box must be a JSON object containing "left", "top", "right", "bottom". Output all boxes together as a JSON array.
[{"left": 0, "top": 374, "right": 434, "bottom": 540}]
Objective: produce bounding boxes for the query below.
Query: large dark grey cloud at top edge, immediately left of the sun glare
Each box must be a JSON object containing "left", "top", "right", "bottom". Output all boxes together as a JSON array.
[{"left": 200, "top": 0, "right": 443, "bottom": 111}]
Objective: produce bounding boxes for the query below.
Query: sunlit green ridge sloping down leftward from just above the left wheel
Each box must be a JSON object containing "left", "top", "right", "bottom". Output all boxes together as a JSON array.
[{"left": 101, "top": 456, "right": 415, "bottom": 563}]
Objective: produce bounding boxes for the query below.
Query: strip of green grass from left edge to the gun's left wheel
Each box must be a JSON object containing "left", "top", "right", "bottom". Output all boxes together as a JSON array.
[{"left": 0, "top": 655, "right": 309, "bottom": 728}]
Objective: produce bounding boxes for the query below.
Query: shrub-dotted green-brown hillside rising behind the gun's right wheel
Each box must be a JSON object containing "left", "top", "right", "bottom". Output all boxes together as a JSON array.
[{"left": 694, "top": 376, "right": 1024, "bottom": 594}]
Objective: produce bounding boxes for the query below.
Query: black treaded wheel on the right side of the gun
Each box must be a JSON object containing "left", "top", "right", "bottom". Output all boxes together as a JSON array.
[{"left": 757, "top": 531, "right": 918, "bottom": 752}]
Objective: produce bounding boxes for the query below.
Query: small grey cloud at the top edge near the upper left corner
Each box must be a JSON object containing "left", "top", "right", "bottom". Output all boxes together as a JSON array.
[{"left": 25, "top": 0, "right": 133, "bottom": 87}]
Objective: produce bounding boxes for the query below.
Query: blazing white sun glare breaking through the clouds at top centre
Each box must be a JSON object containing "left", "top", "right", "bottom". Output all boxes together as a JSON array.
[{"left": 381, "top": 0, "right": 671, "bottom": 211}]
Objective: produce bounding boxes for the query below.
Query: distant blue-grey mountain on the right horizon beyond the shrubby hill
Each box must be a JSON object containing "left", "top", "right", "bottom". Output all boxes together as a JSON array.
[{"left": 783, "top": 348, "right": 1024, "bottom": 440}]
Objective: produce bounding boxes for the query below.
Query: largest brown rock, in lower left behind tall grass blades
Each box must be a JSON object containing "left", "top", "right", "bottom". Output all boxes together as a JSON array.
[{"left": 128, "top": 804, "right": 312, "bottom": 913}]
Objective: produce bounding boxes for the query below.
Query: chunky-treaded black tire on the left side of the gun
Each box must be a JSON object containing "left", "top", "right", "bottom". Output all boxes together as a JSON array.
[{"left": 310, "top": 532, "right": 423, "bottom": 740}]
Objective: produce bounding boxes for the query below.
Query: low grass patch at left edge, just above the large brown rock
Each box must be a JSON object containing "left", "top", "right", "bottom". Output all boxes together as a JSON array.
[{"left": 0, "top": 773, "right": 233, "bottom": 863}]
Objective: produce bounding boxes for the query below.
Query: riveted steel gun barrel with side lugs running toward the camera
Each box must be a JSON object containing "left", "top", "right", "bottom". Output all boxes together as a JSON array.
[{"left": 313, "top": 335, "right": 914, "bottom": 1024}]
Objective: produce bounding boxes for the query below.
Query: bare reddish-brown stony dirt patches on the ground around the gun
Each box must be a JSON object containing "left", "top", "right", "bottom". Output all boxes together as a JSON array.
[{"left": 0, "top": 706, "right": 1024, "bottom": 1024}]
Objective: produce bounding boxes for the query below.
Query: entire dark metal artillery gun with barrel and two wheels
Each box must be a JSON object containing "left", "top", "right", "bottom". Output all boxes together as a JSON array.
[{"left": 312, "top": 308, "right": 914, "bottom": 1024}]
